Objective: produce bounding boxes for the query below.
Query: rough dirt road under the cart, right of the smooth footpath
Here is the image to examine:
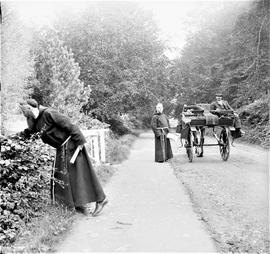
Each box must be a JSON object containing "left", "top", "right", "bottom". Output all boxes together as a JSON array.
[{"left": 172, "top": 137, "right": 269, "bottom": 253}]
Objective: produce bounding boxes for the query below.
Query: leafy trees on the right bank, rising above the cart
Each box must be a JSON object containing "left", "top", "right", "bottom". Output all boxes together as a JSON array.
[{"left": 172, "top": 0, "right": 269, "bottom": 108}]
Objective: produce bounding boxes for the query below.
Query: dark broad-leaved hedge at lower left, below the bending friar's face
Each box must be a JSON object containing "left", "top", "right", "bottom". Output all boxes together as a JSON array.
[{"left": 0, "top": 137, "right": 52, "bottom": 246}]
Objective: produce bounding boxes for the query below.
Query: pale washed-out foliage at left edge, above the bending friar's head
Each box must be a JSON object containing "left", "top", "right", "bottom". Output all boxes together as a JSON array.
[{"left": 0, "top": 2, "right": 32, "bottom": 135}]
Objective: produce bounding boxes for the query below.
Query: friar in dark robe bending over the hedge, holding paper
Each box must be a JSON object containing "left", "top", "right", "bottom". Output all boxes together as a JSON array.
[{"left": 21, "top": 99, "right": 108, "bottom": 216}]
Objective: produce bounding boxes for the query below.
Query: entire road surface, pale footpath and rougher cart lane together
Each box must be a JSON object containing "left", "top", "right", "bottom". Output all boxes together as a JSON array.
[{"left": 57, "top": 132, "right": 269, "bottom": 252}]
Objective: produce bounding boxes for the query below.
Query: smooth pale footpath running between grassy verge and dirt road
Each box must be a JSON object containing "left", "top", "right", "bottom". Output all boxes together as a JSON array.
[{"left": 57, "top": 132, "right": 217, "bottom": 252}]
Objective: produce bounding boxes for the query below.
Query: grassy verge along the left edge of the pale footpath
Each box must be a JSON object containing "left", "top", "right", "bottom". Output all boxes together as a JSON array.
[{"left": 3, "top": 134, "right": 136, "bottom": 253}]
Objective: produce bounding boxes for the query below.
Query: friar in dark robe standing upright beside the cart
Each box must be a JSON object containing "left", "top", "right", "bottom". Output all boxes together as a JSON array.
[{"left": 151, "top": 103, "right": 173, "bottom": 162}]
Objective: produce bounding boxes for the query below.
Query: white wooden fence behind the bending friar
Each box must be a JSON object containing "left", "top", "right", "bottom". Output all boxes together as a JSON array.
[{"left": 82, "top": 129, "right": 109, "bottom": 165}]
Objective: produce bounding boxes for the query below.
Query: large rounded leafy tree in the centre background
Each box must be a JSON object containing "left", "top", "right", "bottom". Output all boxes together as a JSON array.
[{"left": 56, "top": 2, "right": 170, "bottom": 133}]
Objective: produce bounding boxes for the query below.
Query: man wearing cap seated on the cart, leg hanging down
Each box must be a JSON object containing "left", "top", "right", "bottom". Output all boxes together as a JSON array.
[{"left": 210, "top": 93, "right": 245, "bottom": 137}]
